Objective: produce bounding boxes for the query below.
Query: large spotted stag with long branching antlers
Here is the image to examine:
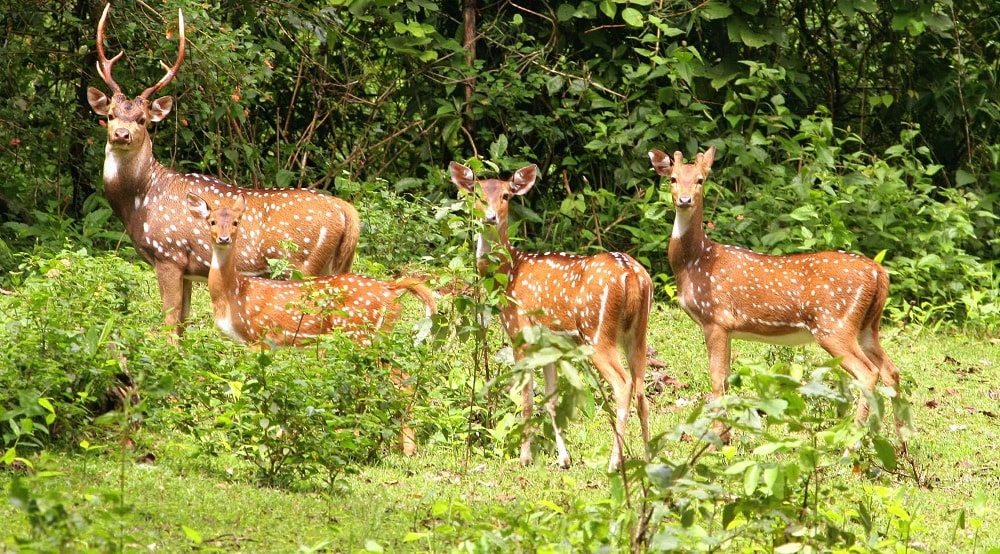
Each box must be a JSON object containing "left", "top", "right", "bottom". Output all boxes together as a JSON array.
[{"left": 87, "top": 4, "right": 361, "bottom": 335}]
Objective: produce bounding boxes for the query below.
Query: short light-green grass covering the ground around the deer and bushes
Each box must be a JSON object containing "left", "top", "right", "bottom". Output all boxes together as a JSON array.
[{"left": 0, "top": 274, "right": 1000, "bottom": 552}]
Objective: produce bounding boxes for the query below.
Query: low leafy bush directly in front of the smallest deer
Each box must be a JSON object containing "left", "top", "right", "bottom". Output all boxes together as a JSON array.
[{"left": 179, "top": 329, "right": 438, "bottom": 488}]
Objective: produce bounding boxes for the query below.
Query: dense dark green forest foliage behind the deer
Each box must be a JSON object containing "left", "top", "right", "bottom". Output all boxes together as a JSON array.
[{"left": 0, "top": 0, "right": 1000, "bottom": 326}]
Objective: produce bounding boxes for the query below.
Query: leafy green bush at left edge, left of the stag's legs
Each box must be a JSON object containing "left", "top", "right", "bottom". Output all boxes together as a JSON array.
[{"left": 0, "top": 250, "right": 160, "bottom": 450}]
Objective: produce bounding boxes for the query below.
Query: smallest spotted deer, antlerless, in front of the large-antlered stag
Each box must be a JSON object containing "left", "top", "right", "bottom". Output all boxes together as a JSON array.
[{"left": 187, "top": 193, "right": 436, "bottom": 454}]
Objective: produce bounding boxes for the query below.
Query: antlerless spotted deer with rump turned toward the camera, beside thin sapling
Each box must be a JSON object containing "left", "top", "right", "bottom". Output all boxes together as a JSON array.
[{"left": 449, "top": 162, "right": 653, "bottom": 471}]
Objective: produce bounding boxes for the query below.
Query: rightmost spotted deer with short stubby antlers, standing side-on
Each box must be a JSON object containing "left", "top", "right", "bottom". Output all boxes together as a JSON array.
[{"left": 649, "top": 146, "right": 905, "bottom": 447}]
